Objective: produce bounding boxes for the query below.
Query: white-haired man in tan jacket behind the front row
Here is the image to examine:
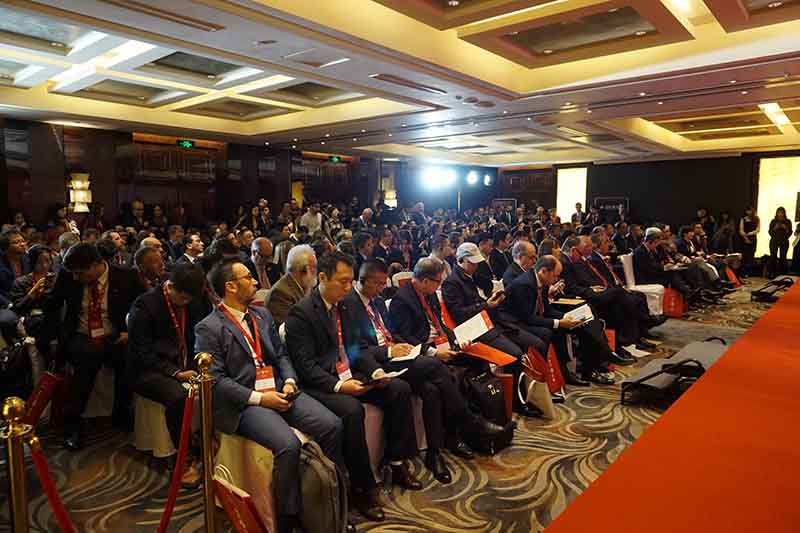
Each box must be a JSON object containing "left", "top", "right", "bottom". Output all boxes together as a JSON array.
[{"left": 264, "top": 244, "right": 317, "bottom": 326}]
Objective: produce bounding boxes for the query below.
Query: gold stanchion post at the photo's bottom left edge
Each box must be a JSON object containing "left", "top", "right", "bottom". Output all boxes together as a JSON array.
[{"left": 0, "top": 396, "right": 31, "bottom": 533}]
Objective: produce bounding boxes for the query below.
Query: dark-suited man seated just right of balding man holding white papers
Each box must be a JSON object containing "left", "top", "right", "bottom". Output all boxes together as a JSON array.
[{"left": 563, "top": 236, "right": 651, "bottom": 354}]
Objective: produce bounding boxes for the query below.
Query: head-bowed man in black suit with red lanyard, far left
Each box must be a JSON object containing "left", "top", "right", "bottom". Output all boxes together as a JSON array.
[{"left": 44, "top": 244, "right": 144, "bottom": 451}]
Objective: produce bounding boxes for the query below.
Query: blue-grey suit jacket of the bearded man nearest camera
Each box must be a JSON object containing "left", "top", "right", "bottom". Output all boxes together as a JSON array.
[{"left": 195, "top": 306, "right": 297, "bottom": 433}]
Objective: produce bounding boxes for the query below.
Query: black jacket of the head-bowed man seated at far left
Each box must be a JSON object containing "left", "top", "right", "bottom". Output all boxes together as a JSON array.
[{"left": 43, "top": 264, "right": 144, "bottom": 349}]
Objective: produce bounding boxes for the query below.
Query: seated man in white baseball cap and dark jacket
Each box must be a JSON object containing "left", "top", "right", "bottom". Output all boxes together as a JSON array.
[{"left": 442, "top": 242, "right": 541, "bottom": 416}]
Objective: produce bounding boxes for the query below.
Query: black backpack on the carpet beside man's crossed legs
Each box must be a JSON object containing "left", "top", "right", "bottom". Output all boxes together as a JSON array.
[{"left": 462, "top": 370, "right": 514, "bottom": 455}]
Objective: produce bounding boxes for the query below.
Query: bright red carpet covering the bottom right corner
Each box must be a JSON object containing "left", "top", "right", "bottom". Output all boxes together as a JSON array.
[{"left": 547, "top": 285, "right": 800, "bottom": 533}]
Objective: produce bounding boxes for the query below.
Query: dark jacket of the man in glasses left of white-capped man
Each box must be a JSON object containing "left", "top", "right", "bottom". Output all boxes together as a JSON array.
[{"left": 384, "top": 283, "right": 456, "bottom": 346}]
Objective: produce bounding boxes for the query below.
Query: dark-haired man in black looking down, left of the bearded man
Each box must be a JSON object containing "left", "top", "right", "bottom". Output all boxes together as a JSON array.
[{"left": 126, "top": 263, "right": 205, "bottom": 488}]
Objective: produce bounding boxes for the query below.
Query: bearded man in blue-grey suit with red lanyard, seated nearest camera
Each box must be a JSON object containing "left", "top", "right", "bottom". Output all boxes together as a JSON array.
[{"left": 195, "top": 258, "right": 342, "bottom": 533}]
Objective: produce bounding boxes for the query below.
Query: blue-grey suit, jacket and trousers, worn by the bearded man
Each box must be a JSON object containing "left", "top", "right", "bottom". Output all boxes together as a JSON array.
[{"left": 195, "top": 307, "right": 343, "bottom": 517}]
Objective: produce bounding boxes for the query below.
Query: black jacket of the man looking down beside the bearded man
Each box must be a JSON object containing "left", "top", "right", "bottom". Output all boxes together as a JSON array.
[{"left": 126, "top": 287, "right": 205, "bottom": 383}]
